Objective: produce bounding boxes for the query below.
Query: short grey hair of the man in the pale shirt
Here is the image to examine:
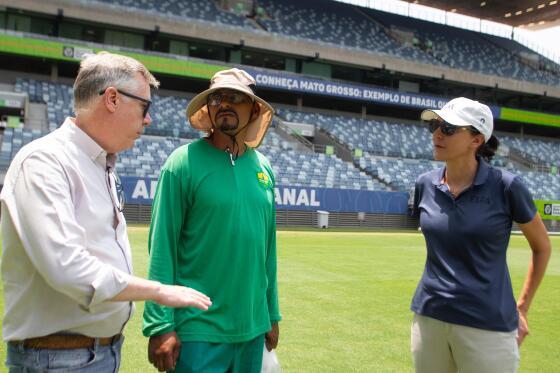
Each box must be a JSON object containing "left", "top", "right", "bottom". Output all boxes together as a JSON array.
[{"left": 74, "top": 52, "right": 159, "bottom": 113}]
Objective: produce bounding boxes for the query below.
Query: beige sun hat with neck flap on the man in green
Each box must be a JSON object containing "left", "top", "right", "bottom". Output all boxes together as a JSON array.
[{"left": 187, "top": 68, "right": 274, "bottom": 148}]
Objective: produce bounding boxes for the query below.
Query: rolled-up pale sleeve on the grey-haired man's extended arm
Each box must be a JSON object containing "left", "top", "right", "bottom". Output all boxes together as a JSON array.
[{"left": 2, "top": 153, "right": 130, "bottom": 309}]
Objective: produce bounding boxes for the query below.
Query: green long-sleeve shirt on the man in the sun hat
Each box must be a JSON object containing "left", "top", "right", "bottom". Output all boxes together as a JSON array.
[{"left": 143, "top": 139, "right": 280, "bottom": 343}]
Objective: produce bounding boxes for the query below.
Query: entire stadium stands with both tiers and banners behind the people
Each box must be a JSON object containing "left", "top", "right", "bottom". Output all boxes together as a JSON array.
[{"left": 0, "top": 0, "right": 560, "bottom": 230}]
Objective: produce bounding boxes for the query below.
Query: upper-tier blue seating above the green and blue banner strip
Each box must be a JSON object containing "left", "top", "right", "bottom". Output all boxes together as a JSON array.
[{"left": 79, "top": 0, "right": 560, "bottom": 86}]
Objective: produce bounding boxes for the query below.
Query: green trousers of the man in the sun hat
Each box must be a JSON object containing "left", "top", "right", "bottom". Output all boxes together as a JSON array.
[{"left": 175, "top": 334, "right": 264, "bottom": 373}]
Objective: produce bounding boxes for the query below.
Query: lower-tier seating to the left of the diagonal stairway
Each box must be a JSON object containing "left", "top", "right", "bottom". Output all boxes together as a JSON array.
[{"left": 7, "top": 79, "right": 387, "bottom": 190}]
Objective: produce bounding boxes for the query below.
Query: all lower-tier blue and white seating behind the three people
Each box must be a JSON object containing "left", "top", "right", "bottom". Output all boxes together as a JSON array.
[{"left": 5, "top": 79, "right": 560, "bottom": 198}]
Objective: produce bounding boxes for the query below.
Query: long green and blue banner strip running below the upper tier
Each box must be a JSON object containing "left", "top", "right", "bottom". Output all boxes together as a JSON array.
[{"left": 4, "top": 33, "right": 560, "bottom": 127}]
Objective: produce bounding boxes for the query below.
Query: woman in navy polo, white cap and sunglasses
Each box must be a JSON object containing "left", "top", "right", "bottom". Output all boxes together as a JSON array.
[{"left": 411, "top": 97, "right": 551, "bottom": 373}]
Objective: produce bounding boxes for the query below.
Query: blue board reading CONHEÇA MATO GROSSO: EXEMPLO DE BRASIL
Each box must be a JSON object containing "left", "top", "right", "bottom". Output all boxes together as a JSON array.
[{"left": 244, "top": 67, "right": 500, "bottom": 118}]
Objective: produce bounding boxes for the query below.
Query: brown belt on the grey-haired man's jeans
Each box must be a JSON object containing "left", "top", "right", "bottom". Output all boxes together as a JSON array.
[{"left": 9, "top": 334, "right": 121, "bottom": 350}]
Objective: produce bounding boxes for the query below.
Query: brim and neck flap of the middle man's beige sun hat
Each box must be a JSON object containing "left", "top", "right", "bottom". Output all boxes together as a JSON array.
[{"left": 186, "top": 85, "right": 274, "bottom": 148}]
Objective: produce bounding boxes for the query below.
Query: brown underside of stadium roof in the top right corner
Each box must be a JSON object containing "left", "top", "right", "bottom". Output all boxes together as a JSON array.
[{"left": 404, "top": 0, "right": 560, "bottom": 29}]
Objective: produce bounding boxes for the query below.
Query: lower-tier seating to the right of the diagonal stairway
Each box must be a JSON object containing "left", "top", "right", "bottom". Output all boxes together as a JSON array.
[{"left": 277, "top": 108, "right": 560, "bottom": 199}]
